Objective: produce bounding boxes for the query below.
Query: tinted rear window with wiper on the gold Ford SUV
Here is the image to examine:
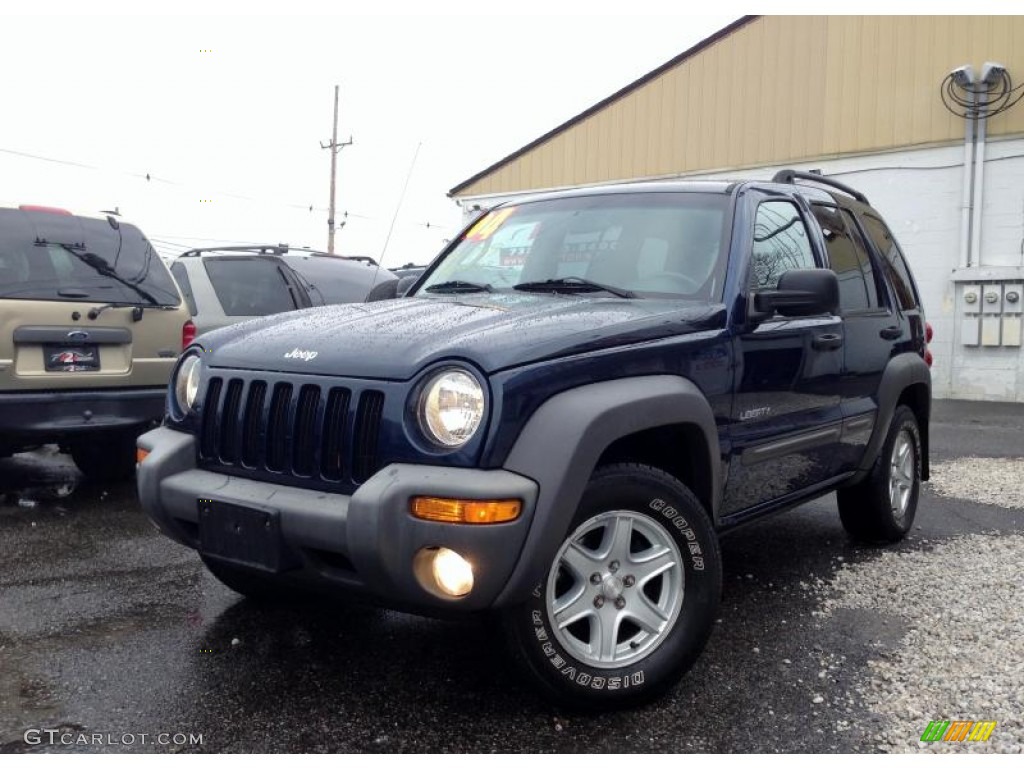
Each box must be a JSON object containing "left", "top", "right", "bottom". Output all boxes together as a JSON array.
[{"left": 0, "top": 209, "right": 181, "bottom": 306}]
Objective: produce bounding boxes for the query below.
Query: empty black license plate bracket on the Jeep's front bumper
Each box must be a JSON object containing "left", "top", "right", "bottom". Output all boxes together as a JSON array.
[{"left": 198, "top": 499, "right": 295, "bottom": 573}]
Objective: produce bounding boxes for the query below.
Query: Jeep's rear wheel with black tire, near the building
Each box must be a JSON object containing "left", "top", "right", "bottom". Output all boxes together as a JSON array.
[{"left": 836, "top": 406, "right": 922, "bottom": 544}]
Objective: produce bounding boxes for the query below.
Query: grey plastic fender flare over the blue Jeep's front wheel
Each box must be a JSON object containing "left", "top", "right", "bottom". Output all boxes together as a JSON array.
[{"left": 495, "top": 375, "right": 722, "bottom": 606}]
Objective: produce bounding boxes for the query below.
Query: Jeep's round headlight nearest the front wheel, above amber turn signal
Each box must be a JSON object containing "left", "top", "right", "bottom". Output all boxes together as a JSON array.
[{"left": 420, "top": 369, "right": 483, "bottom": 447}]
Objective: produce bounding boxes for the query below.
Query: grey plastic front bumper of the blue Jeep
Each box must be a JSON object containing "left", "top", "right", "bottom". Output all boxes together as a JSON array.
[{"left": 137, "top": 427, "right": 538, "bottom": 613}]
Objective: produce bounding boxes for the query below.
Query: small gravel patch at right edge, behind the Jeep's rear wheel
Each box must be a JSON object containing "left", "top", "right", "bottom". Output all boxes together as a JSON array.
[{"left": 929, "top": 457, "right": 1024, "bottom": 509}]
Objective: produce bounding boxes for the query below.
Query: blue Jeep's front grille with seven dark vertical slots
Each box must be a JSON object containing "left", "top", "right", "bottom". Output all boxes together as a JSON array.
[{"left": 199, "top": 376, "right": 384, "bottom": 490}]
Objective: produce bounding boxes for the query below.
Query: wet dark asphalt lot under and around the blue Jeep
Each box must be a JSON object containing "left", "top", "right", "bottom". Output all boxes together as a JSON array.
[{"left": 0, "top": 402, "right": 1024, "bottom": 753}]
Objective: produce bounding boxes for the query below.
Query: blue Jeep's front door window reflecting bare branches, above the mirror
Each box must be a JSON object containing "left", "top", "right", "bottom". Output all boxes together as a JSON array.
[{"left": 751, "top": 200, "right": 817, "bottom": 291}]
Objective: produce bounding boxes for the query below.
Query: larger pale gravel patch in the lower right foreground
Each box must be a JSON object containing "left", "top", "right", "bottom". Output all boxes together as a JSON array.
[{"left": 816, "top": 535, "right": 1024, "bottom": 754}]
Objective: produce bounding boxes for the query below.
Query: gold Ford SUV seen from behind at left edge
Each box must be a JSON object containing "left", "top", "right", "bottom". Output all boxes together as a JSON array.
[{"left": 0, "top": 206, "right": 195, "bottom": 480}]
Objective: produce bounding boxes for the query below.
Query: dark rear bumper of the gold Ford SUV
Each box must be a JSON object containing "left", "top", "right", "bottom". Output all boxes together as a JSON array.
[{"left": 0, "top": 386, "right": 167, "bottom": 441}]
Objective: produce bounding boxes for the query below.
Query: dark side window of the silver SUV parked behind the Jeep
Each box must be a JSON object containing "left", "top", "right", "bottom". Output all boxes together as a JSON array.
[{"left": 203, "top": 256, "right": 298, "bottom": 315}]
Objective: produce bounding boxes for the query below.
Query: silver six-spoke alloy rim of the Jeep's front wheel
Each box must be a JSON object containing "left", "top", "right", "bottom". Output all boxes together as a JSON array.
[{"left": 545, "top": 510, "right": 685, "bottom": 669}]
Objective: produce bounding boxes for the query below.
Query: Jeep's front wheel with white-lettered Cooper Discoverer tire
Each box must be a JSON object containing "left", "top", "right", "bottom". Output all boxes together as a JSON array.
[{"left": 499, "top": 464, "right": 722, "bottom": 711}]
